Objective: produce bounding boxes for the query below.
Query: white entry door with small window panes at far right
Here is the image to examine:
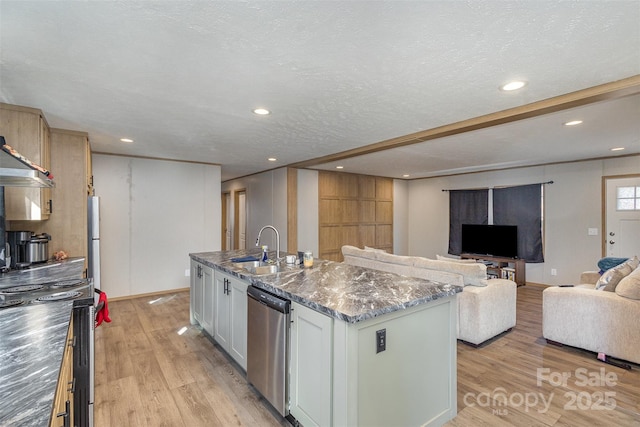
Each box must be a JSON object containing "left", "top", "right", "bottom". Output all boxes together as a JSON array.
[{"left": 604, "top": 176, "right": 640, "bottom": 258}]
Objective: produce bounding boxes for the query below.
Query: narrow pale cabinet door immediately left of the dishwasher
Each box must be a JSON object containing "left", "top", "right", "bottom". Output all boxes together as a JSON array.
[{"left": 229, "top": 277, "right": 249, "bottom": 371}]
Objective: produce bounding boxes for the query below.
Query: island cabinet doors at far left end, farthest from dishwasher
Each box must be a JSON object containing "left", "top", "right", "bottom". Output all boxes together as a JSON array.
[{"left": 190, "top": 260, "right": 214, "bottom": 335}]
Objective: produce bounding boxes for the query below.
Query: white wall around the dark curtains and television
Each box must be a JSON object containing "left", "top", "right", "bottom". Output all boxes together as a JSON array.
[{"left": 408, "top": 156, "right": 640, "bottom": 284}]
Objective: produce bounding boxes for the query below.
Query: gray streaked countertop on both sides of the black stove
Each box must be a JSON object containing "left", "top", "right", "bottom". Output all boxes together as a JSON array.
[{"left": 0, "top": 258, "right": 84, "bottom": 426}]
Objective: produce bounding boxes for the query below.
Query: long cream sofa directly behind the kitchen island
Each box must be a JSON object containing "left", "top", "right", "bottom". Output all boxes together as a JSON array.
[{"left": 342, "top": 245, "right": 517, "bottom": 346}]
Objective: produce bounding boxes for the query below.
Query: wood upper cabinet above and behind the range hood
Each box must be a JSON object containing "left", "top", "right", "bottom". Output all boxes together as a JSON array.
[{"left": 0, "top": 103, "right": 52, "bottom": 221}]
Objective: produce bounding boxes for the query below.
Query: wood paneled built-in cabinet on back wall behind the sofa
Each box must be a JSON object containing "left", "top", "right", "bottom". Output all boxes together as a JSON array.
[{"left": 318, "top": 171, "right": 393, "bottom": 261}]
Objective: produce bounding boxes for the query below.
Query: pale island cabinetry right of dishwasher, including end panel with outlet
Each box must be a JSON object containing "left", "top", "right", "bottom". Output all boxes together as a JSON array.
[{"left": 289, "top": 296, "right": 457, "bottom": 427}]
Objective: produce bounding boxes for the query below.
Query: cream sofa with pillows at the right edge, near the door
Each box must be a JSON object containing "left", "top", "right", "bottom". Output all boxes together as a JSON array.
[{"left": 542, "top": 257, "right": 640, "bottom": 364}]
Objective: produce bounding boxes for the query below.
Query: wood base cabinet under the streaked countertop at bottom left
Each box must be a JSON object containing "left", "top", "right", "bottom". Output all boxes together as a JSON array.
[{"left": 49, "top": 316, "right": 74, "bottom": 427}]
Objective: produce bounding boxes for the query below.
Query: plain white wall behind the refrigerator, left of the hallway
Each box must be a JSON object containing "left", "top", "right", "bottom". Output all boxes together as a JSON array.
[{"left": 92, "top": 154, "right": 221, "bottom": 297}]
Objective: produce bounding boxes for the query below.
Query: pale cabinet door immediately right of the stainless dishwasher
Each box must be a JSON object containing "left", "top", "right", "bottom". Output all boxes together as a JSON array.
[{"left": 289, "top": 302, "right": 333, "bottom": 427}]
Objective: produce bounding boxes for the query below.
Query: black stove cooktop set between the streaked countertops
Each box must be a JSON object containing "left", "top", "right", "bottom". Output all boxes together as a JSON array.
[{"left": 0, "top": 279, "right": 94, "bottom": 309}]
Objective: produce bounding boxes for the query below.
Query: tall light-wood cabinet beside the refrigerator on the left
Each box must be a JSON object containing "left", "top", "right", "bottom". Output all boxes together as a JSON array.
[{"left": 10, "top": 128, "right": 93, "bottom": 258}]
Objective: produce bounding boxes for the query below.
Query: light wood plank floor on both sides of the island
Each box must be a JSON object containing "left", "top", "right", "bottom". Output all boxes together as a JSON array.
[{"left": 95, "top": 286, "right": 640, "bottom": 427}]
